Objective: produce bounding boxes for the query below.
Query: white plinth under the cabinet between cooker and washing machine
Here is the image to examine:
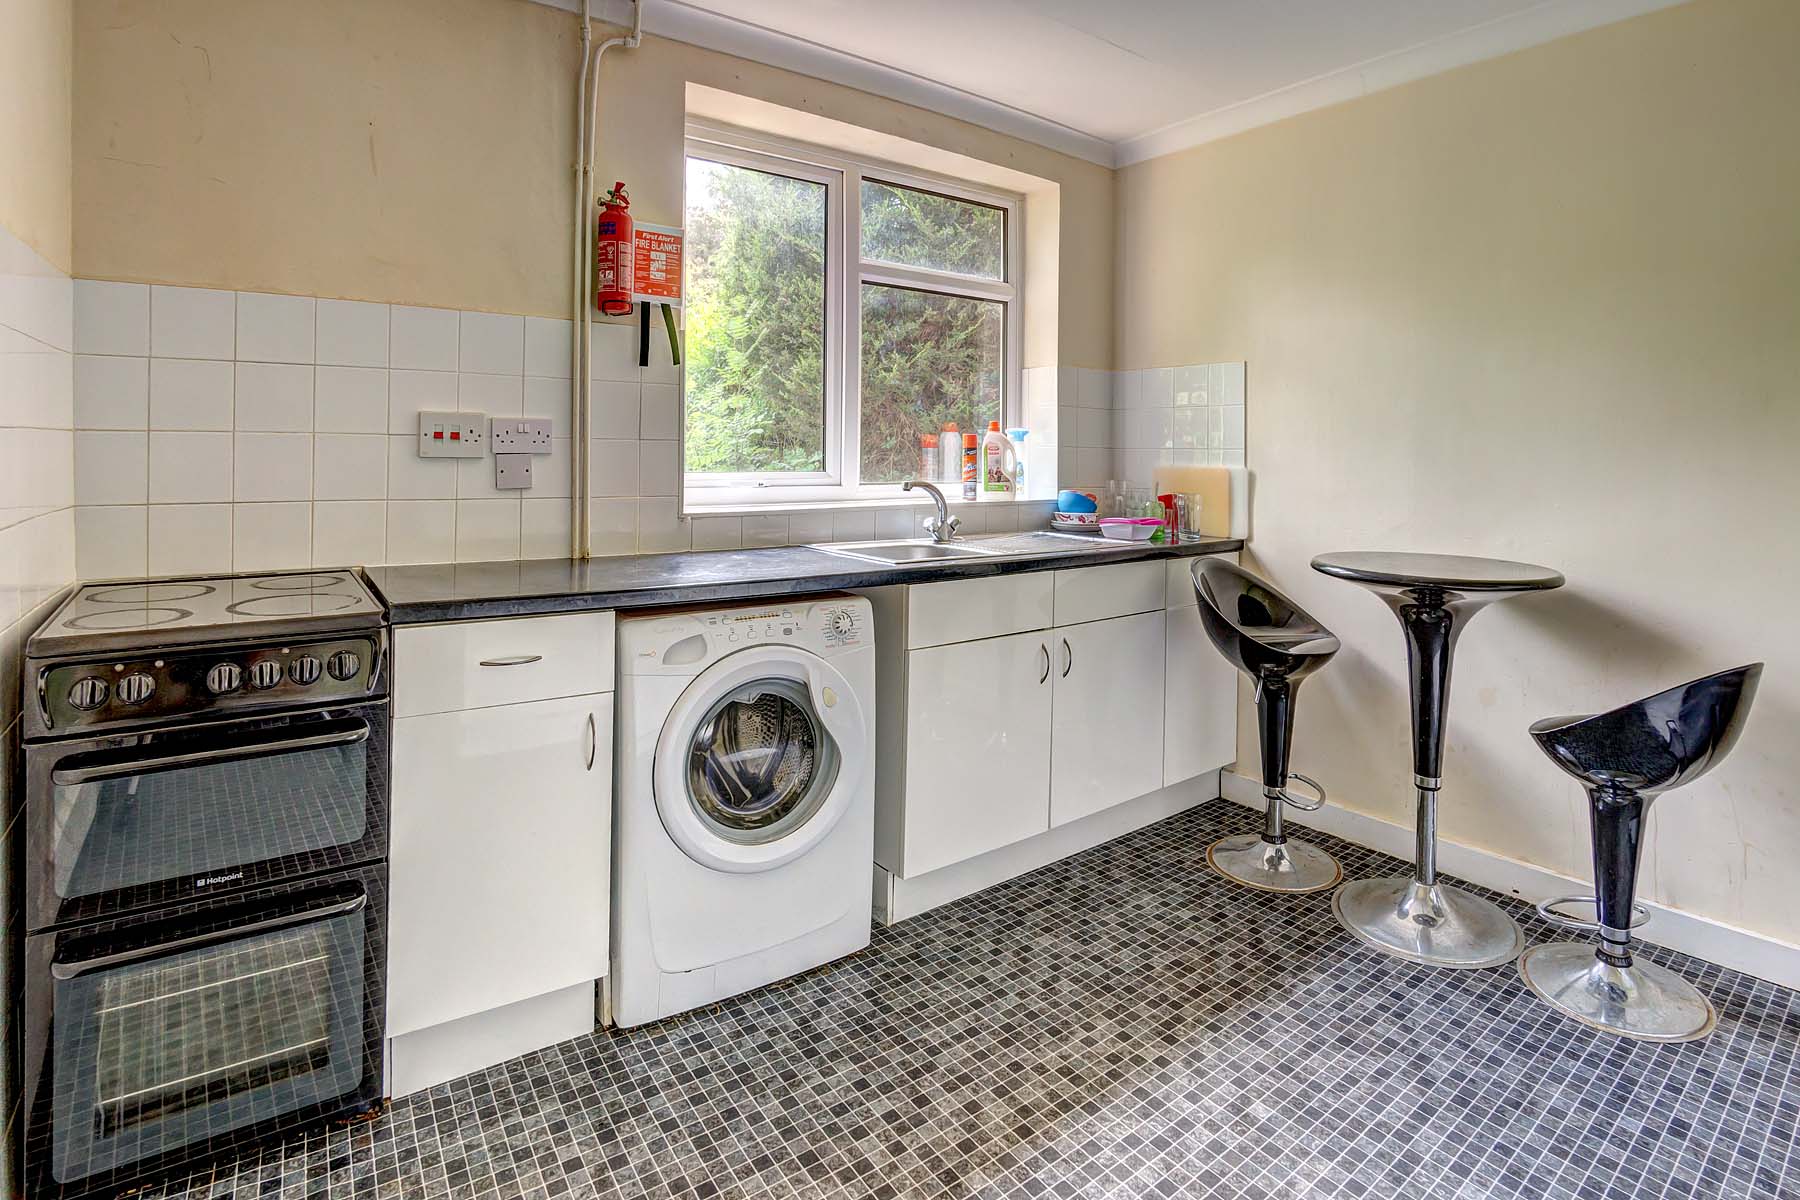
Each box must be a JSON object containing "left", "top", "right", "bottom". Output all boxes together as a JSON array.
[{"left": 387, "top": 981, "right": 598, "bottom": 1099}]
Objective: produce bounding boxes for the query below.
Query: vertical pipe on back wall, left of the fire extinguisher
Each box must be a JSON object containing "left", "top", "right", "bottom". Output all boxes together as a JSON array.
[{"left": 569, "top": 0, "right": 644, "bottom": 558}]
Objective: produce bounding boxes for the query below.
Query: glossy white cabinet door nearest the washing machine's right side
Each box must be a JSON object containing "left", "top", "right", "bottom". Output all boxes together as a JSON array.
[{"left": 889, "top": 631, "right": 1053, "bottom": 878}]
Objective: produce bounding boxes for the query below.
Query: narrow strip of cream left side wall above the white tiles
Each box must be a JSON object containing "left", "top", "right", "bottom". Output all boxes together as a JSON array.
[{"left": 0, "top": 0, "right": 72, "bottom": 273}]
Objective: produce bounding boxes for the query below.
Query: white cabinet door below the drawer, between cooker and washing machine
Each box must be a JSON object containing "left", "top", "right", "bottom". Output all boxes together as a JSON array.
[{"left": 387, "top": 694, "right": 612, "bottom": 1036}]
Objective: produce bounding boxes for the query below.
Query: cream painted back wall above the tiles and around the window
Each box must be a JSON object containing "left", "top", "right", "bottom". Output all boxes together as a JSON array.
[{"left": 74, "top": 0, "right": 1114, "bottom": 367}]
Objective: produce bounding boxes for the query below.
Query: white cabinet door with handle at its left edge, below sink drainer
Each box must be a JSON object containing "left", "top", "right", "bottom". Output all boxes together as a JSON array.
[{"left": 1049, "top": 612, "right": 1163, "bottom": 826}]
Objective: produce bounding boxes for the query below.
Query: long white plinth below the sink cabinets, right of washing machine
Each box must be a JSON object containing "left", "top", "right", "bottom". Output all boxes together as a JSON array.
[{"left": 875, "top": 770, "right": 1219, "bottom": 925}]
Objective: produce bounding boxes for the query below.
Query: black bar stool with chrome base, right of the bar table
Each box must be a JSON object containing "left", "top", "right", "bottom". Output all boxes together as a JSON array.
[{"left": 1519, "top": 662, "right": 1762, "bottom": 1042}]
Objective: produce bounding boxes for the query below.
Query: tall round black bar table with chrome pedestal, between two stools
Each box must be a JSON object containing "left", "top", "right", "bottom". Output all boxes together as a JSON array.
[{"left": 1312, "top": 551, "right": 1562, "bottom": 968}]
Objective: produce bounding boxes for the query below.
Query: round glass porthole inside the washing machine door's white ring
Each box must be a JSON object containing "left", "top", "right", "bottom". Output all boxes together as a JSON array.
[{"left": 688, "top": 680, "right": 839, "bottom": 846}]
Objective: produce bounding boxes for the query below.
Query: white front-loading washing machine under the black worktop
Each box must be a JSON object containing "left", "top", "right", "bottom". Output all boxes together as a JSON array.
[{"left": 610, "top": 596, "right": 875, "bottom": 1025}]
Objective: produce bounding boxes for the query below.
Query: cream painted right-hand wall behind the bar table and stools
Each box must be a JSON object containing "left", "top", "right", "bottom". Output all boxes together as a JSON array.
[{"left": 1116, "top": 0, "right": 1800, "bottom": 941}]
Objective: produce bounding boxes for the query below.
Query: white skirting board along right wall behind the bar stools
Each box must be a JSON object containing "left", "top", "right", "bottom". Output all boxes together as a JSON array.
[{"left": 1220, "top": 770, "right": 1800, "bottom": 988}]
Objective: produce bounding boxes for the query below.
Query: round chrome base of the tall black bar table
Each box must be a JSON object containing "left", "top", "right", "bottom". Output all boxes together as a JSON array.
[{"left": 1332, "top": 876, "right": 1525, "bottom": 970}]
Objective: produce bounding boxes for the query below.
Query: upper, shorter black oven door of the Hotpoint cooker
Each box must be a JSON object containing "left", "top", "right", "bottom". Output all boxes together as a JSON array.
[{"left": 25, "top": 700, "right": 389, "bottom": 930}]
